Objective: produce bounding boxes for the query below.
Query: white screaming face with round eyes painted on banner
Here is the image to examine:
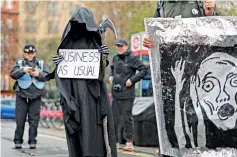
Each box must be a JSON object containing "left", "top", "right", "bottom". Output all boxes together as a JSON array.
[{"left": 196, "top": 53, "right": 237, "bottom": 130}]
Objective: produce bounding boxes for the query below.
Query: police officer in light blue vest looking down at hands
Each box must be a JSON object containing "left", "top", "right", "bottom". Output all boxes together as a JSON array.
[{"left": 10, "top": 45, "right": 49, "bottom": 149}]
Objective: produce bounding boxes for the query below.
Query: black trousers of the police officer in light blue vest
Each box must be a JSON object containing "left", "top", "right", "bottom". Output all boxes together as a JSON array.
[{"left": 14, "top": 95, "right": 41, "bottom": 144}]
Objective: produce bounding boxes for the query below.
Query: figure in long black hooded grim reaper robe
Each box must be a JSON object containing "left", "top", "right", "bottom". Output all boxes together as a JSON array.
[{"left": 47, "top": 8, "right": 117, "bottom": 157}]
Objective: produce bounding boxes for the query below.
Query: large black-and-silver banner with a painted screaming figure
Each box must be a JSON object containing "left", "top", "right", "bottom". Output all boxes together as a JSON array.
[{"left": 145, "top": 17, "right": 237, "bottom": 157}]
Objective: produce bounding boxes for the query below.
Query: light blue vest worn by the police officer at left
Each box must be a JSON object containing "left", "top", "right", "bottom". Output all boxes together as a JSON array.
[{"left": 17, "top": 59, "right": 44, "bottom": 89}]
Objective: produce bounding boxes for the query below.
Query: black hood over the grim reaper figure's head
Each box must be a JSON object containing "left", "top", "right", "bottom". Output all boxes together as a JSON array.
[{"left": 61, "top": 7, "right": 100, "bottom": 41}]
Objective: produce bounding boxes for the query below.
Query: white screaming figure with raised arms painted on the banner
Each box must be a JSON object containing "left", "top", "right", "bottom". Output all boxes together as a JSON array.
[{"left": 171, "top": 52, "right": 237, "bottom": 148}]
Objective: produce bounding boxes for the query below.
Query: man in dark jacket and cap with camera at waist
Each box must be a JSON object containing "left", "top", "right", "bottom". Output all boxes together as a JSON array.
[{"left": 109, "top": 39, "right": 147, "bottom": 151}]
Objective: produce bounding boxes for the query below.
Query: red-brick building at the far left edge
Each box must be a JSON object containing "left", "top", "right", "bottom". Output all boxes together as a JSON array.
[{"left": 0, "top": 0, "right": 19, "bottom": 97}]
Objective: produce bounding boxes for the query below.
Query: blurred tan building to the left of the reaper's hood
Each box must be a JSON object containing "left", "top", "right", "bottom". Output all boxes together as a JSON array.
[{"left": 19, "top": 1, "right": 86, "bottom": 60}]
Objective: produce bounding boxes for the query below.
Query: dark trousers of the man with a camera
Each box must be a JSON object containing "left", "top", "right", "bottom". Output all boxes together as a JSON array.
[{"left": 112, "top": 99, "right": 134, "bottom": 142}]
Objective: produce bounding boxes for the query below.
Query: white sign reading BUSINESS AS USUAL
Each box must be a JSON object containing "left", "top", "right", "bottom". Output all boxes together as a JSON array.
[{"left": 57, "top": 49, "right": 101, "bottom": 79}]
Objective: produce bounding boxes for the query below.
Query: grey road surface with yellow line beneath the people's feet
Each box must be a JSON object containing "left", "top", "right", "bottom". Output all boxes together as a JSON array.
[{"left": 1, "top": 120, "right": 157, "bottom": 157}]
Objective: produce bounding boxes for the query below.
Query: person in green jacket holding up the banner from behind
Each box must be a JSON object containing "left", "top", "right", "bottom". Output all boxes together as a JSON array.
[{"left": 143, "top": 0, "right": 218, "bottom": 48}]
